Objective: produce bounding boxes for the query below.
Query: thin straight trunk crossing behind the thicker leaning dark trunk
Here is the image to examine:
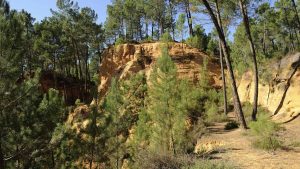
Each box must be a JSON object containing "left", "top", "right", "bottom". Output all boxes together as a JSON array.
[{"left": 215, "top": 0, "right": 228, "bottom": 115}]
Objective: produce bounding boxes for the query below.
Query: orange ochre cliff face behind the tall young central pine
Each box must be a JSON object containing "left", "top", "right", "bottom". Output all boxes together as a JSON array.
[{"left": 98, "top": 42, "right": 221, "bottom": 96}]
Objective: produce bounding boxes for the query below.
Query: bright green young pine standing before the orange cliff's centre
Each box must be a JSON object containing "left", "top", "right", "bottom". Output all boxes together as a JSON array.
[{"left": 147, "top": 48, "right": 187, "bottom": 155}]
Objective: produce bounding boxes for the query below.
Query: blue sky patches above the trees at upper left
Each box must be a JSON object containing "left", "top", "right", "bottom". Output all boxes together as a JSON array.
[{"left": 8, "top": 0, "right": 111, "bottom": 23}]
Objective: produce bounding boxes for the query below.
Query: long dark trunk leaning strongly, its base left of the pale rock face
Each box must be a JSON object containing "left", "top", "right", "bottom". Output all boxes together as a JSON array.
[{"left": 200, "top": 0, "right": 247, "bottom": 129}]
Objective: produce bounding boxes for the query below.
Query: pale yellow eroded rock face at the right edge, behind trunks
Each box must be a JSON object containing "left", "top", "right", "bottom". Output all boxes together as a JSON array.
[{"left": 238, "top": 53, "right": 300, "bottom": 122}]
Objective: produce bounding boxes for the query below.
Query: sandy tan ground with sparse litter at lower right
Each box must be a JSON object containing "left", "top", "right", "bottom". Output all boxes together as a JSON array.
[{"left": 201, "top": 114, "right": 300, "bottom": 169}]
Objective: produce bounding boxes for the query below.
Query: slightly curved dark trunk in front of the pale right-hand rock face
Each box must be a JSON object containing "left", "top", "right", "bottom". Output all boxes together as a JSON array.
[{"left": 239, "top": 0, "right": 258, "bottom": 121}]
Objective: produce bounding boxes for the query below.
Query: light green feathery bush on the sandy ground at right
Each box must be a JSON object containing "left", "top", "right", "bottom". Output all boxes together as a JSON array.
[{"left": 249, "top": 115, "right": 282, "bottom": 151}]
